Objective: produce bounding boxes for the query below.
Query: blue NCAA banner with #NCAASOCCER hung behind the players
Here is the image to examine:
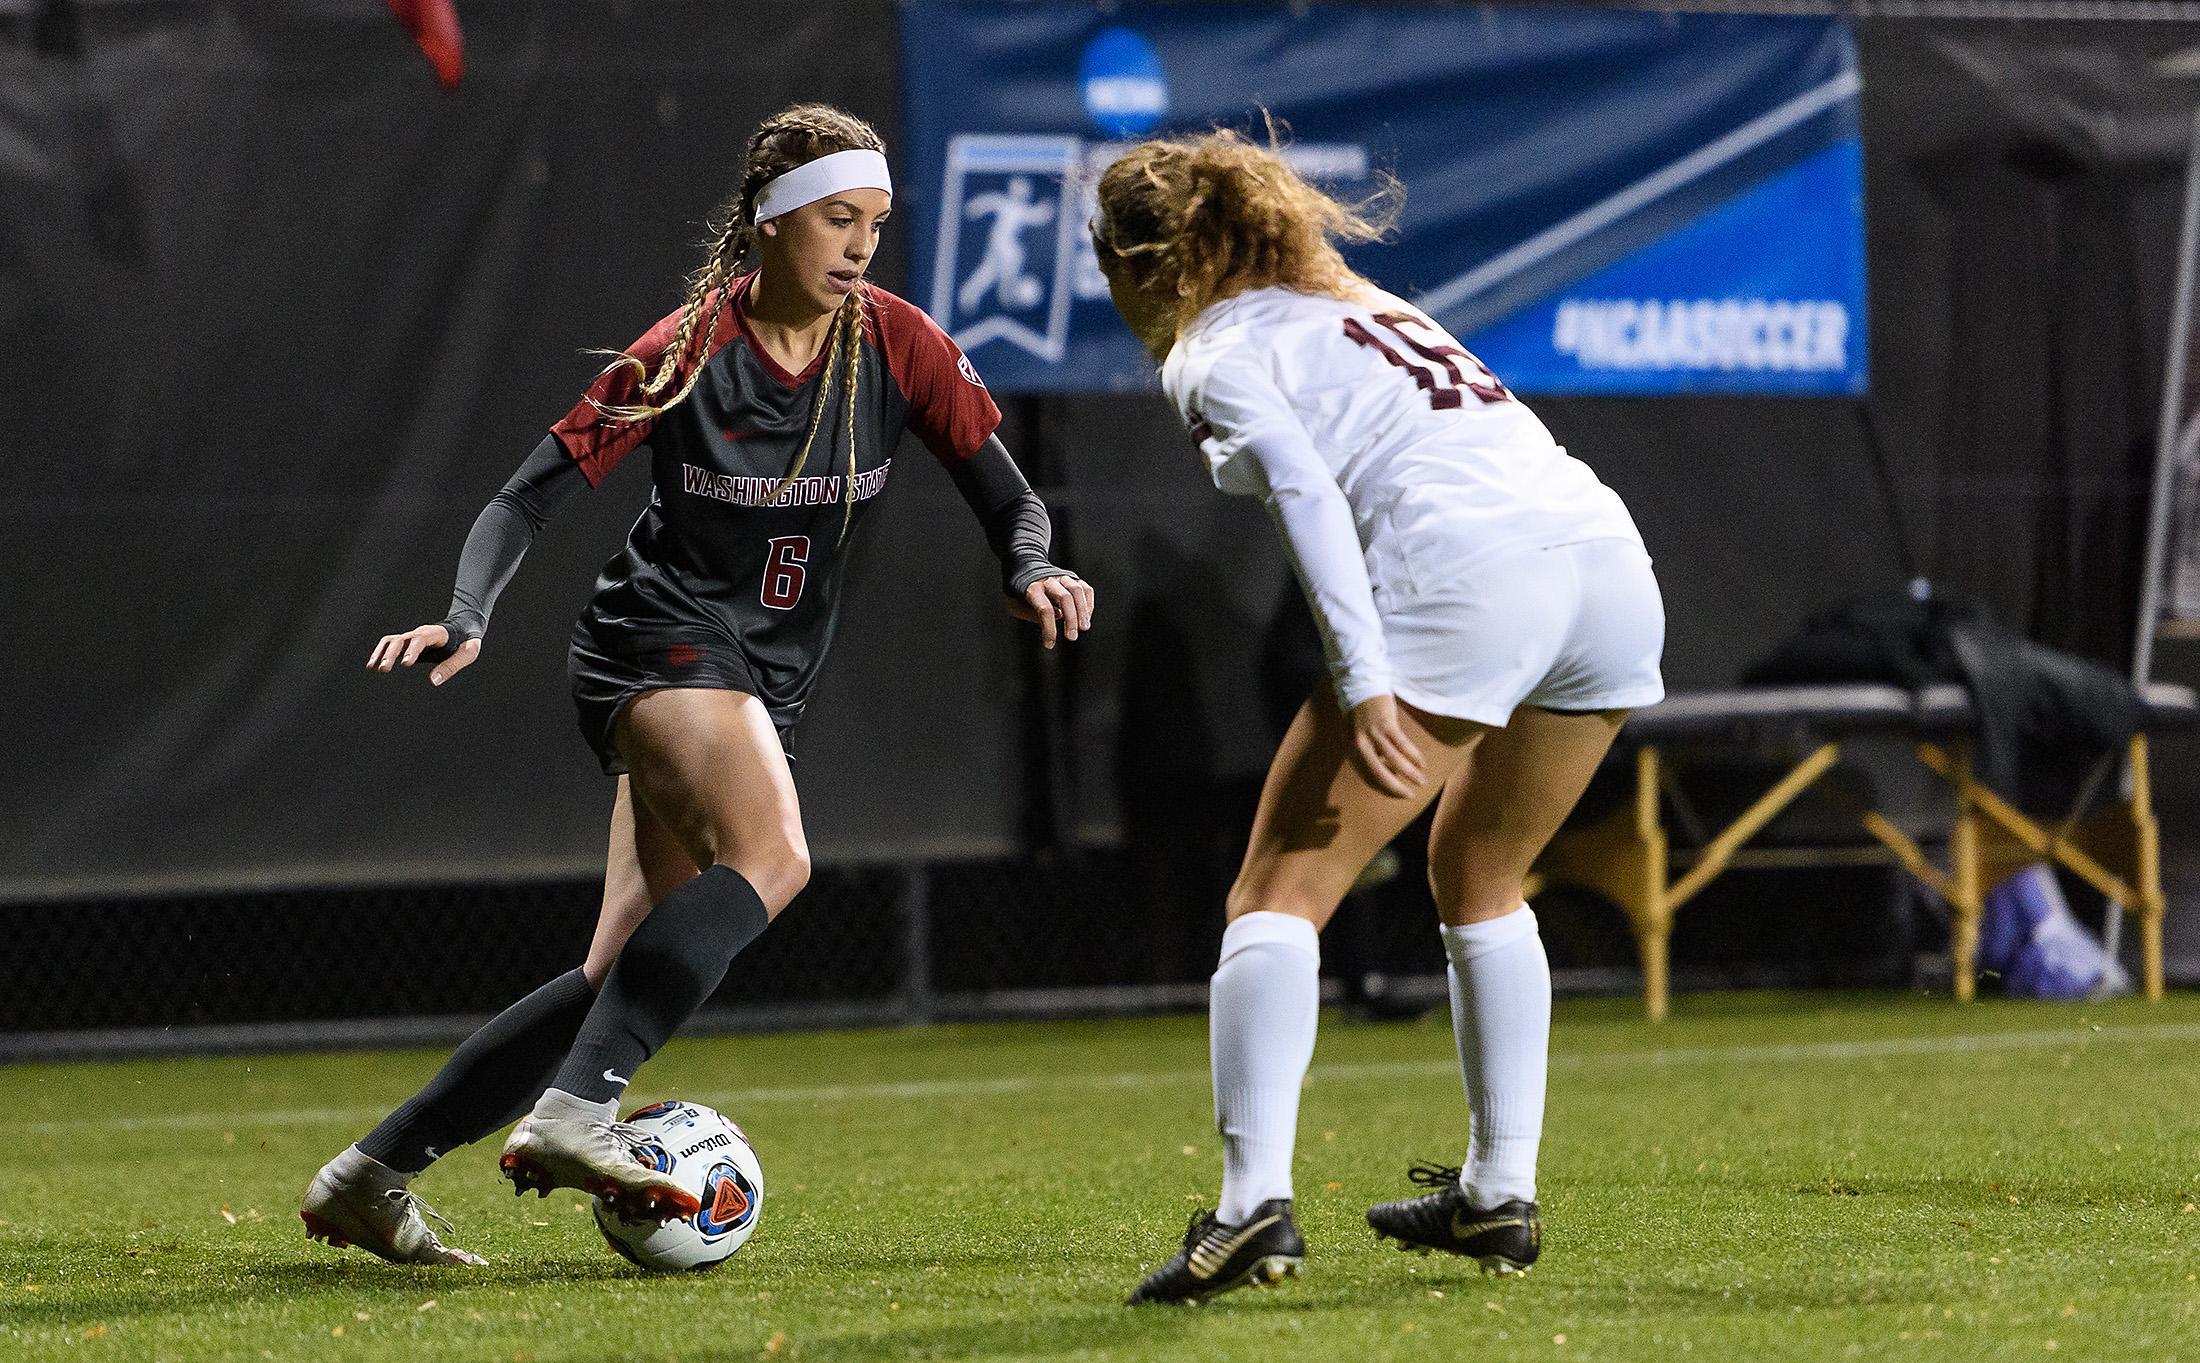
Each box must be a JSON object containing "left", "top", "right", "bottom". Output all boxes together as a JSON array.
[{"left": 895, "top": 0, "right": 1866, "bottom": 394}]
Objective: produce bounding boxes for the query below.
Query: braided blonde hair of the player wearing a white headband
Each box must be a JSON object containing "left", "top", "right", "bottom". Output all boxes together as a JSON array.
[{"left": 596, "top": 103, "right": 887, "bottom": 539}]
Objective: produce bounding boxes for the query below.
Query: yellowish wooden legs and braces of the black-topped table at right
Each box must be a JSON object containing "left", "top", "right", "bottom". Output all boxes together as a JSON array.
[{"left": 1527, "top": 734, "right": 2167, "bottom": 1022}]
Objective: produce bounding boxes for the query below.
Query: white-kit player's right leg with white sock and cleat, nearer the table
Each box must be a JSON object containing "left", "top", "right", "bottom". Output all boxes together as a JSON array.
[{"left": 1368, "top": 706, "right": 1626, "bottom": 1273}]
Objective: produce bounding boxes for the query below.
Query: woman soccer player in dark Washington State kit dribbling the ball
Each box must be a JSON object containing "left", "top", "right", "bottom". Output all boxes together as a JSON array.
[{"left": 301, "top": 106, "right": 1093, "bottom": 1264}]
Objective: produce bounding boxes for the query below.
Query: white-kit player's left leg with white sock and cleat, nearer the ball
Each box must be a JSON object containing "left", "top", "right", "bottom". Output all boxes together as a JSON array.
[{"left": 1131, "top": 686, "right": 1485, "bottom": 1306}]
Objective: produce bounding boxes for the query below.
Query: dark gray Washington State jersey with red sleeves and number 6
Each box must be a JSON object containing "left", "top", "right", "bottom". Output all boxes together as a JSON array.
[{"left": 552, "top": 275, "right": 1001, "bottom": 723}]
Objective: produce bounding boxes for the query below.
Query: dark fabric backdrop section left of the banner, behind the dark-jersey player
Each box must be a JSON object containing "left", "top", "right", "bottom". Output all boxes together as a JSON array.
[{"left": 0, "top": 0, "right": 1019, "bottom": 897}]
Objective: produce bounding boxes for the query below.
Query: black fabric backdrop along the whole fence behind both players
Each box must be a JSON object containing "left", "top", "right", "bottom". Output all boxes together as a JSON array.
[{"left": 0, "top": 10, "right": 2180, "bottom": 899}]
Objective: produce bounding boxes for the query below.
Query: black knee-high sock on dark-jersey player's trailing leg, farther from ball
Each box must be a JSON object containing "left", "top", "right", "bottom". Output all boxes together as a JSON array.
[{"left": 359, "top": 969, "right": 596, "bottom": 1174}]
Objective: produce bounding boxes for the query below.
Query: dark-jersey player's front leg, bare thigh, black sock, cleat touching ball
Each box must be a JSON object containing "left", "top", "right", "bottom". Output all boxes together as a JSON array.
[{"left": 499, "top": 690, "right": 810, "bottom": 1218}]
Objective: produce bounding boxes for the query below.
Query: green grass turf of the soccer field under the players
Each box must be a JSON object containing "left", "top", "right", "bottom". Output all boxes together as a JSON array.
[{"left": 0, "top": 996, "right": 2200, "bottom": 1363}]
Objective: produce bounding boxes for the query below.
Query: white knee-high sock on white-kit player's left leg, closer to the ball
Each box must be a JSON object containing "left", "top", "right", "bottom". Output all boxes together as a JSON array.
[{"left": 1208, "top": 912, "right": 1322, "bottom": 1225}]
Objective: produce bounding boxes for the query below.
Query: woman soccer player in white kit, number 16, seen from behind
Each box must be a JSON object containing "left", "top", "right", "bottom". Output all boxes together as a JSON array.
[{"left": 1093, "top": 132, "right": 1665, "bottom": 1304}]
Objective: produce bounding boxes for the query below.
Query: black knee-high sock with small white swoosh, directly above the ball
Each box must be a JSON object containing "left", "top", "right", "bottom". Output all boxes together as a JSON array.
[{"left": 552, "top": 866, "right": 772, "bottom": 1104}]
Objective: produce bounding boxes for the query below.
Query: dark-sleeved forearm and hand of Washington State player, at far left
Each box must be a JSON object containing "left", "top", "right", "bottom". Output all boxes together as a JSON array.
[{"left": 367, "top": 435, "right": 587, "bottom": 686}]
